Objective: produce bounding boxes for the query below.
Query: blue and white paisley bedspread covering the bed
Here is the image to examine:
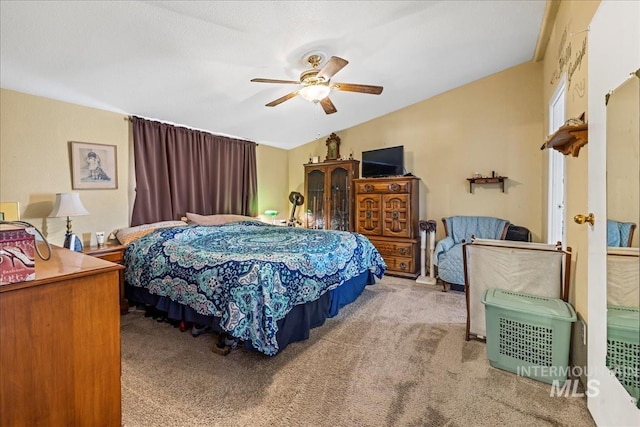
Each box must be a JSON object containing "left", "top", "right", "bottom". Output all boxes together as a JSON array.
[{"left": 125, "top": 221, "right": 386, "bottom": 355}]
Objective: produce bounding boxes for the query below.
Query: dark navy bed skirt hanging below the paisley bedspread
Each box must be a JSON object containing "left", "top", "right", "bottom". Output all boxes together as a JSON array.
[{"left": 126, "top": 270, "right": 375, "bottom": 352}]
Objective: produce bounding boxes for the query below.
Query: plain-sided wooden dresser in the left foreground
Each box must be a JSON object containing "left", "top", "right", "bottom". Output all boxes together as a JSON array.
[{"left": 0, "top": 247, "right": 123, "bottom": 426}]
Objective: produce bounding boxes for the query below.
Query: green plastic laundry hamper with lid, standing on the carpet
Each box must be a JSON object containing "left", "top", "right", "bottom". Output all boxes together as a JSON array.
[{"left": 482, "top": 289, "right": 576, "bottom": 385}]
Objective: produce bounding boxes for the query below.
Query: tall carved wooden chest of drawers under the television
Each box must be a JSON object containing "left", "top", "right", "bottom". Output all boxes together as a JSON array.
[{"left": 354, "top": 176, "right": 420, "bottom": 278}]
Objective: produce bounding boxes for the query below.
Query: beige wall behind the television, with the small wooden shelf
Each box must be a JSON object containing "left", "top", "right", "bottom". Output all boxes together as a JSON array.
[{"left": 289, "top": 62, "right": 544, "bottom": 241}]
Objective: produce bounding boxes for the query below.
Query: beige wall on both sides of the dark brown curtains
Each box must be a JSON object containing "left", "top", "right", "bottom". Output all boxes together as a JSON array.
[{"left": 0, "top": 89, "right": 289, "bottom": 245}]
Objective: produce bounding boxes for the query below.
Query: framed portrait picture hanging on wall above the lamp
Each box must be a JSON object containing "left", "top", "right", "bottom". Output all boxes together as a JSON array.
[{"left": 70, "top": 141, "right": 118, "bottom": 190}]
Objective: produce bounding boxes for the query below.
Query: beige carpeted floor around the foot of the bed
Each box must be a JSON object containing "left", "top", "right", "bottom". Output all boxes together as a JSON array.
[{"left": 121, "top": 277, "right": 594, "bottom": 427}]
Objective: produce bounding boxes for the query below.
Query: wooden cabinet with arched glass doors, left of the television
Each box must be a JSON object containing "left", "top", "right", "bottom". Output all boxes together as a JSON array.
[{"left": 303, "top": 160, "right": 360, "bottom": 231}]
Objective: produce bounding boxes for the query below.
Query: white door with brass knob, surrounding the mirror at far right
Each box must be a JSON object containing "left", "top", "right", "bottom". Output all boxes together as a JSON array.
[{"left": 588, "top": 1, "right": 640, "bottom": 426}]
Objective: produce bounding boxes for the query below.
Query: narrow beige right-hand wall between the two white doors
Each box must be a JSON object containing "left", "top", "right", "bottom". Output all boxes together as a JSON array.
[{"left": 542, "top": 0, "right": 604, "bottom": 320}]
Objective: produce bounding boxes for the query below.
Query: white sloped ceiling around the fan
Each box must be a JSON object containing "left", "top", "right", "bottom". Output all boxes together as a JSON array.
[{"left": 0, "top": 0, "right": 545, "bottom": 149}]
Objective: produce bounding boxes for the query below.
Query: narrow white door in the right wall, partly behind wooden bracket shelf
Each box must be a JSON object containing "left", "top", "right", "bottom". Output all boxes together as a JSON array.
[{"left": 547, "top": 80, "right": 566, "bottom": 247}]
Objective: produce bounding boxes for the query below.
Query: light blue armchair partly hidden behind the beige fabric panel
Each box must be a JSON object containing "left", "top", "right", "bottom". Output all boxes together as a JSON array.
[{"left": 433, "top": 216, "right": 509, "bottom": 291}]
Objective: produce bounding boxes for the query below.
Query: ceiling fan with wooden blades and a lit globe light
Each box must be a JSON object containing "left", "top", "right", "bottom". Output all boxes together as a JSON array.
[{"left": 251, "top": 54, "right": 382, "bottom": 114}]
